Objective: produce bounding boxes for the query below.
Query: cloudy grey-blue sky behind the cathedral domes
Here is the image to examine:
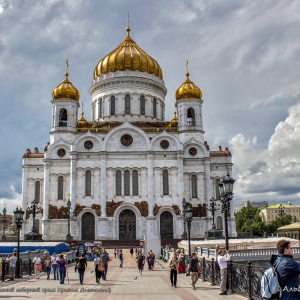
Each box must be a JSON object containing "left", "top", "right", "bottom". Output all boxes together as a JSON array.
[{"left": 0, "top": 0, "right": 300, "bottom": 211}]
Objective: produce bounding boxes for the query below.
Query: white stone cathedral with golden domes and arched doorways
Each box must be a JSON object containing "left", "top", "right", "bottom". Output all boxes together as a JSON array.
[{"left": 22, "top": 27, "right": 236, "bottom": 241}]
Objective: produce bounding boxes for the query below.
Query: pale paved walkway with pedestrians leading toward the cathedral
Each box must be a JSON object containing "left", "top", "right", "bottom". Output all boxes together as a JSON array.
[{"left": 0, "top": 249, "right": 246, "bottom": 300}]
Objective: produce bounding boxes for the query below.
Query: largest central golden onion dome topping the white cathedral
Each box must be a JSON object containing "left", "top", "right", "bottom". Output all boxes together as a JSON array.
[{"left": 94, "top": 27, "right": 163, "bottom": 79}]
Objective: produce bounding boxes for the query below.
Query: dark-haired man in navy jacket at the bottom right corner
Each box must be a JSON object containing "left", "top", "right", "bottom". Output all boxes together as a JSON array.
[{"left": 271, "top": 240, "right": 300, "bottom": 300}]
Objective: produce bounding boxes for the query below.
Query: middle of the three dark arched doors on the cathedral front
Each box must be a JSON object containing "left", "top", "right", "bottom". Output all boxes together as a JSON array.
[{"left": 119, "top": 209, "right": 136, "bottom": 240}]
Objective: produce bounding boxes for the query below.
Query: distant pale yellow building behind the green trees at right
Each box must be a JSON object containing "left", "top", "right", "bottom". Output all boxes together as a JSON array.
[{"left": 260, "top": 202, "right": 300, "bottom": 224}]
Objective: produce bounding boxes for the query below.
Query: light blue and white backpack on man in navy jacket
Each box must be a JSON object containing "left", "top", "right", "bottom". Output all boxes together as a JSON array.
[{"left": 260, "top": 259, "right": 282, "bottom": 299}]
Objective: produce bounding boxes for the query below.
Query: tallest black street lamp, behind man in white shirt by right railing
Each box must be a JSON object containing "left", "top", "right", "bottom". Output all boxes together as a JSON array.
[{"left": 219, "top": 173, "right": 235, "bottom": 250}]
